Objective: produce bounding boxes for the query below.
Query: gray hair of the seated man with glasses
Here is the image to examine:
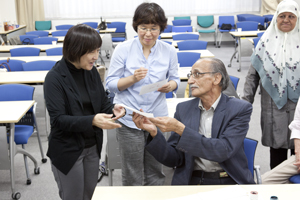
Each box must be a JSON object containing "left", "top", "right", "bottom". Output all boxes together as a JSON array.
[{"left": 199, "top": 58, "right": 230, "bottom": 91}]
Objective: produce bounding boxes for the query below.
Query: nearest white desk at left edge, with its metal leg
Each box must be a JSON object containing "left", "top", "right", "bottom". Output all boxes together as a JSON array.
[{"left": 0, "top": 100, "right": 39, "bottom": 198}]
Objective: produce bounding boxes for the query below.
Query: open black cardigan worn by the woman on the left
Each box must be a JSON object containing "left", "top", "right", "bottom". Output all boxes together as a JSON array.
[{"left": 44, "top": 58, "right": 114, "bottom": 174}]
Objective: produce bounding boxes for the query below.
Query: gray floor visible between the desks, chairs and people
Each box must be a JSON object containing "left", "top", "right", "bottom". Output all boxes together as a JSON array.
[{"left": 0, "top": 39, "right": 269, "bottom": 200}]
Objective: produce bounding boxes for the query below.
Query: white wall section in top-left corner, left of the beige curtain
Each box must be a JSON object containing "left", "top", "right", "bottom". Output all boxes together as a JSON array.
[{"left": 0, "top": 0, "right": 17, "bottom": 23}]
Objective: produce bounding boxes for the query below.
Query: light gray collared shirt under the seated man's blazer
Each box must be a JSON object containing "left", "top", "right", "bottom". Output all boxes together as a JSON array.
[{"left": 194, "top": 95, "right": 223, "bottom": 172}]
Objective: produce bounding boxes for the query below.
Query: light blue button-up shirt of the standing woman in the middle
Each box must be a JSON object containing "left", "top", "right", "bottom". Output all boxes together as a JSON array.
[{"left": 106, "top": 37, "right": 180, "bottom": 129}]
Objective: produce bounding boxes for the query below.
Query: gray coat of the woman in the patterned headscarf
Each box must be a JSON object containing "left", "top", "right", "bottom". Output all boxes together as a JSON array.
[{"left": 242, "top": 65, "right": 297, "bottom": 149}]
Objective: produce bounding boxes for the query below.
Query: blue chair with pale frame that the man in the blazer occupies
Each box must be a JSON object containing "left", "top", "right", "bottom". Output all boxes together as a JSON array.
[{"left": 244, "top": 138, "right": 262, "bottom": 184}]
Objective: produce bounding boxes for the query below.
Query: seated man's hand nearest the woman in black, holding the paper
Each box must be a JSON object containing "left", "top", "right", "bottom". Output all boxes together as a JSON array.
[{"left": 132, "top": 109, "right": 157, "bottom": 137}]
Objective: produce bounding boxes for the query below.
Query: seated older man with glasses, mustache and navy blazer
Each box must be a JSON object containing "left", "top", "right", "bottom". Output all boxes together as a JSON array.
[{"left": 133, "top": 58, "right": 255, "bottom": 185}]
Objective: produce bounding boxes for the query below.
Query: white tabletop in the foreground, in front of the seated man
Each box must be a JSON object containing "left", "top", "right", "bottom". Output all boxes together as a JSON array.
[{"left": 92, "top": 184, "right": 300, "bottom": 200}]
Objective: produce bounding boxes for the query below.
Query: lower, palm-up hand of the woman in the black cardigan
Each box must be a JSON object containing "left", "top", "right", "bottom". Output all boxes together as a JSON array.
[{"left": 92, "top": 113, "right": 122, "bottom": 129}]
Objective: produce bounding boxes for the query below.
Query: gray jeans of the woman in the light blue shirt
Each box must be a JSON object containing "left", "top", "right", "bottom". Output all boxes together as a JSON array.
[{"left": 116, "top": 124, "right": 165, "bottom": 186}]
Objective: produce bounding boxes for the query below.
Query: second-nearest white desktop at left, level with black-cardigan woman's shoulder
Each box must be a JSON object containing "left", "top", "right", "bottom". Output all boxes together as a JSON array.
[{"left": 0, "top": 71, "right": 48, "bottom": 84}]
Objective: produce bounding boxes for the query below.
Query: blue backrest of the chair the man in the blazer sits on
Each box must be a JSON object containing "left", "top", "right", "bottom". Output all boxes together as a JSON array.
[{"left": 244, "top": 138, "right": 258, "bottom": 176}]
